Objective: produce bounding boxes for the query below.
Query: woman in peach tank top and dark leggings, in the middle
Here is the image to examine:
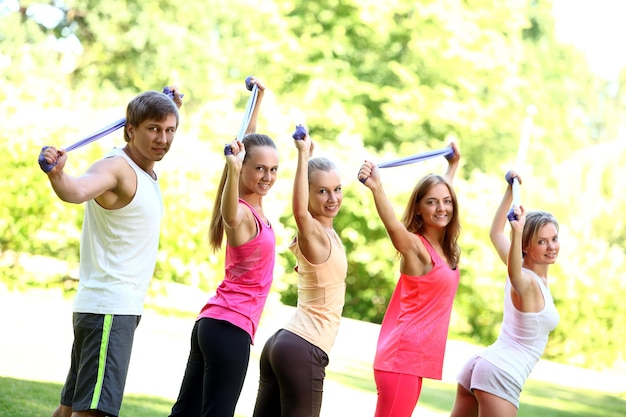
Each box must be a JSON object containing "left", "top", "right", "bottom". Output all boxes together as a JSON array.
[{"left": 253, "top": 124, "right": 348, "bottom": 417}]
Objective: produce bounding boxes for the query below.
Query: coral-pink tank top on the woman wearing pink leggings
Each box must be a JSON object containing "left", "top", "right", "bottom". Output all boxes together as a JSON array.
[{"left": 374, "top": 235, "right": 460, "bottom": 379}]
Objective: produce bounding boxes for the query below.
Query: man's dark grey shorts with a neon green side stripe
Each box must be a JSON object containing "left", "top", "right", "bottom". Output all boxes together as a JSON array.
[{"left": 61, "top": 313, "right": 141, "bottom": 416}]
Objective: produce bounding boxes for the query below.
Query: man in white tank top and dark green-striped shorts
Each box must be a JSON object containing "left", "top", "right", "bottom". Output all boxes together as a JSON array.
[{"left": 40, "top": 87, "right": 182, "bottom": 417}]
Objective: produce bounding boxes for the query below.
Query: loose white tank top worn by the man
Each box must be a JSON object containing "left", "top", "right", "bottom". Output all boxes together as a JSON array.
[{"left": 74, "top": 148, "right": 163, "bottom": 315}]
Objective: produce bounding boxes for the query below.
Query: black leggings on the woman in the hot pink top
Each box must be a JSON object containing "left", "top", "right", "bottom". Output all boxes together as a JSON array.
[{"left": 170, "top": 318, "right": 250, "bottom": 417}]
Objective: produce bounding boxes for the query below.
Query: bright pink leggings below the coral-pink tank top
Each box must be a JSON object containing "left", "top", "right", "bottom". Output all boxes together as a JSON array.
[{"left": 374, "top": 370, "right": 422, "bottom": 417}]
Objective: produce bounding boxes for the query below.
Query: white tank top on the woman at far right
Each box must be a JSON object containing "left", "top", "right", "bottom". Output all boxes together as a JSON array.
[{"left": 480, "top": 268, "right": 559, "bottom": 388}]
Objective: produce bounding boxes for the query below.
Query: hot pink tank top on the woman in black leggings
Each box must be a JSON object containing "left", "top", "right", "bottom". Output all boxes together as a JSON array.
[{"left": 198, "top": 199, "right": 276, "bottom": 343}]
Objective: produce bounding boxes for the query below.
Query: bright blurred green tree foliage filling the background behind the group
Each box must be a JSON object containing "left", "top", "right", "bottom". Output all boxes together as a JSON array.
[{"left": 0, "top": 0, "right": 626, "bottom": 367}]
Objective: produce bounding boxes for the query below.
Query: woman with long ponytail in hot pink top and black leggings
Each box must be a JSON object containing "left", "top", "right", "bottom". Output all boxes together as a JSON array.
[{"left": 170, "top": 78, "right": 278, "bottom": 417}]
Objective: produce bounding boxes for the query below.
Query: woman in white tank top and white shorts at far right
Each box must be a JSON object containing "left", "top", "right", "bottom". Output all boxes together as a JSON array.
[{"left": 451, "top": 172, "right": 560, "bottom": 417}]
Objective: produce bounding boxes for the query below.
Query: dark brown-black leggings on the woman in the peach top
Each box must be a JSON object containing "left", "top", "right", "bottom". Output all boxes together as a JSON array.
[{"left": 253, "top": 329, "right": 328, "bottom": 417}]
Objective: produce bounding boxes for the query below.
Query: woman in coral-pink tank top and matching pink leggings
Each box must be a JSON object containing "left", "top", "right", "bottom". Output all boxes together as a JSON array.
[{"left": 359, "top": 143, "right": 461, "bottom": 417}]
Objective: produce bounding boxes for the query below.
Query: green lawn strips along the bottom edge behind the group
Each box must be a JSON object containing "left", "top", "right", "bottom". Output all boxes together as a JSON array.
[{"left": 0, "top": 369, "right": 626, "bottom": 417}]
